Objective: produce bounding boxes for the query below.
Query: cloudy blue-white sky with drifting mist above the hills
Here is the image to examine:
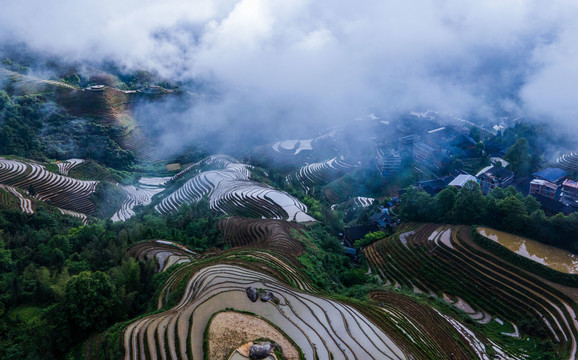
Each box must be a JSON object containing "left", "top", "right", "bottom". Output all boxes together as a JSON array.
[{"left": 0, "top": 0, "right": 578, "bottom": 149}]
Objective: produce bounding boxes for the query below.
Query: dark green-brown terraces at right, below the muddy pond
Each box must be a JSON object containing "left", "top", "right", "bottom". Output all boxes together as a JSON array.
[{"left": 363, "top": 224, "right": 578, "bottom": 359}]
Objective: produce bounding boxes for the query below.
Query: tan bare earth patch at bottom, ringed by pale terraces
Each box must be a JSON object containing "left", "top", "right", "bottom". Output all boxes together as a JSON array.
[{"left": 208, "top": 311, "right": 299, "bottom": 360}]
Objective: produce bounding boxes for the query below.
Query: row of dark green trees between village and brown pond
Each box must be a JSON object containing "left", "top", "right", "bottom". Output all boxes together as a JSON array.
[{"left": 399, "top": 181, "right": 578, "bottom": 251}]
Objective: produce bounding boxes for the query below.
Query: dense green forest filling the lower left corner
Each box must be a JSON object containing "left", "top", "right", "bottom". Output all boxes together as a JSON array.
[{"left": 0, "top": 201, "right": 221, "bottom": 359}]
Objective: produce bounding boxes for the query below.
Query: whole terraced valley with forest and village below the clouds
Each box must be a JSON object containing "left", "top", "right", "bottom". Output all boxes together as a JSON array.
[{"left": 0, "top": 56, "right": 578, "bottom": 360}]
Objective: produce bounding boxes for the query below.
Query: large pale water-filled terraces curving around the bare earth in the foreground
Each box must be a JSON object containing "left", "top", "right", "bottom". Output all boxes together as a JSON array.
[{"left": 124, "top": 265, "right": 407, "bottom": 359}]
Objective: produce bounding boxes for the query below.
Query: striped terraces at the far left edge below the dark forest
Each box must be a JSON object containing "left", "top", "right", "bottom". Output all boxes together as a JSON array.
[{"left": 0, "top": 158, "right": 98, "bottom": 214}]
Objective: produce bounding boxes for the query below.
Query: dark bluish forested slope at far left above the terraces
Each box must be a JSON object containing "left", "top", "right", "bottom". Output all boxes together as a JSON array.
[{"left": 0, "top": 90, "right": 134, "bottom": 169}]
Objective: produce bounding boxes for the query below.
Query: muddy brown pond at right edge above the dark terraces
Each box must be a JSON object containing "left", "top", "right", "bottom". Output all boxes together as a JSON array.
[{"left": 478, "top": 228, "right": 578, "bottom": 274}]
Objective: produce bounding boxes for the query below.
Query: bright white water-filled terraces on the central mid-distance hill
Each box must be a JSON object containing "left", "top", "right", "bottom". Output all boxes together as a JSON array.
[{"left": 155, "top": 157, "right": 315, "bottom": 222}]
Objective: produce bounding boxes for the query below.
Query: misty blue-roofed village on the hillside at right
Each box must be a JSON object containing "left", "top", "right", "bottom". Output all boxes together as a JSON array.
[{"left": 340, "top": 113, "right": 578, "bottom": 255}]
